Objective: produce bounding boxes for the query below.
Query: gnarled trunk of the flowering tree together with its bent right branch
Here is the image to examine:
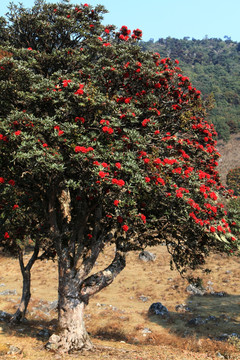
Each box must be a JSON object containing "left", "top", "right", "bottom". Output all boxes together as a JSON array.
[{"left": 46, "top": 242, "right": 125, "bottom": 353}]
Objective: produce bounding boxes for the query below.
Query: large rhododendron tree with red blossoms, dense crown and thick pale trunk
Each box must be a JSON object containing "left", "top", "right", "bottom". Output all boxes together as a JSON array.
[{"left": 0, "top": 1, "right": 238, "bottom": 351}]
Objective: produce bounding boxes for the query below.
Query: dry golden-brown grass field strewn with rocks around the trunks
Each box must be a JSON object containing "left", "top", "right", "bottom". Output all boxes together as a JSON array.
[{"left": 0, "top": 246, "right": 240, "bottom": 360}]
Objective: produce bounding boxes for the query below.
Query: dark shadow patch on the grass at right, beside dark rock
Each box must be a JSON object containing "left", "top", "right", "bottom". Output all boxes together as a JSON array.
[{"left": 148, "top": 294, "right": 240, "bottom": 340}]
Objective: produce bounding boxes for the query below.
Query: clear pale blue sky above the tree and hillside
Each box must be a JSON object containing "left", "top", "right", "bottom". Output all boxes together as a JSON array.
[{"left": 0, "top": 0, "right": 240, "bottom": 42}]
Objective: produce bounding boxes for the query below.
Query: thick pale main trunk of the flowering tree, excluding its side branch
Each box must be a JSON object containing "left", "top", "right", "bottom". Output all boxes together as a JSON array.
[{"left": 46, "top": 261, "right": 93, "bottom": 353}]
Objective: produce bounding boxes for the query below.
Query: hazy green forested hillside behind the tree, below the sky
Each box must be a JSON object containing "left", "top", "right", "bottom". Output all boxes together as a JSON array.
[{"left": 141, "top": 37, "right": 240, "bottom": 140}]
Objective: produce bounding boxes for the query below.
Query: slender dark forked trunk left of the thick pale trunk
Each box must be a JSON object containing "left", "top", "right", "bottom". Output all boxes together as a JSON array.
[{"left": 11, "top": 243, "right": 39, "bottom": 323}]
